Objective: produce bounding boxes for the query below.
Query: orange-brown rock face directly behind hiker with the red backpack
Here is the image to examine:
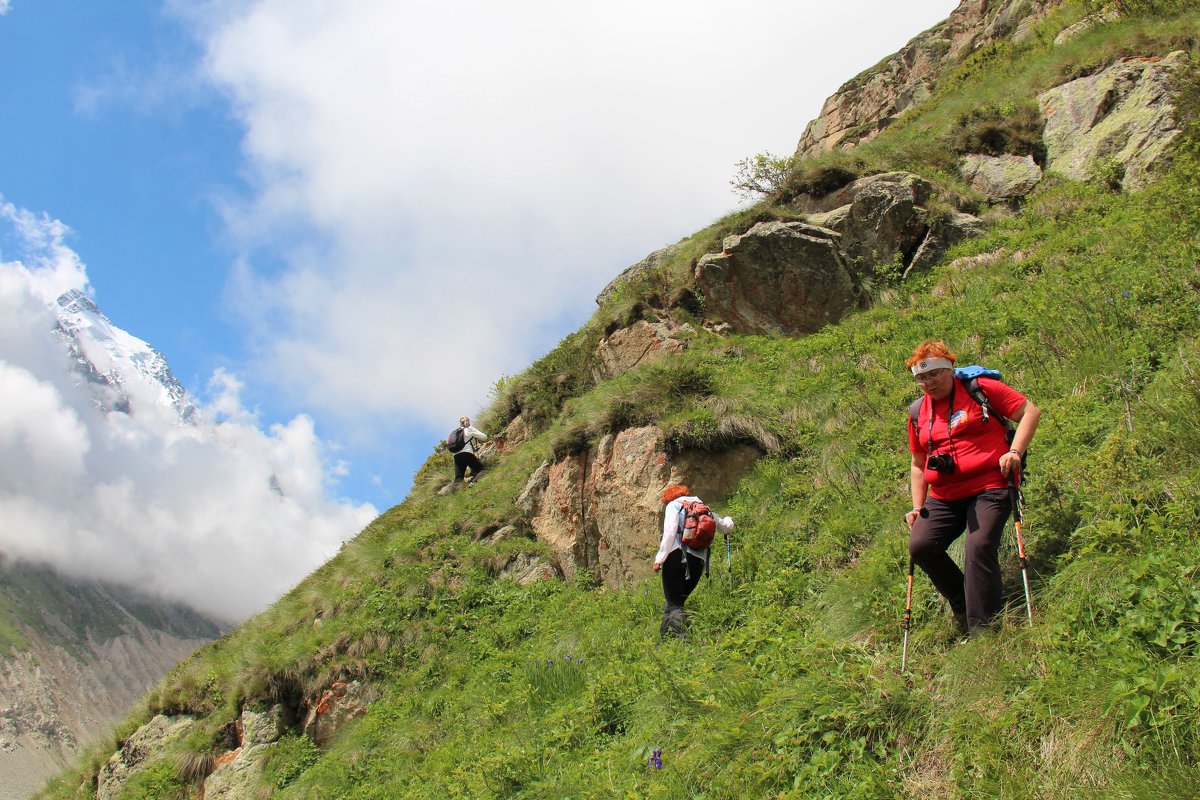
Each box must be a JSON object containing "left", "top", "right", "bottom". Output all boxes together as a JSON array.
[{"left": 517, "top": 426, "right": 761, "bottom": 588}]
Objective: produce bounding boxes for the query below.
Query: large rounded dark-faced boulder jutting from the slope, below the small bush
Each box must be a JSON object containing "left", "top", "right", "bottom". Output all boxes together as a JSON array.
[{"left": 696, "top": 222, "right": 859, "bottom": 335}]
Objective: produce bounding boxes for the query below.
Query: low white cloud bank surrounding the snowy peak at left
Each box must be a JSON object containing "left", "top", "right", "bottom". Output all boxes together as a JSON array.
[{"left": 0, "top": 205, "right": 377, "bottom": 619}]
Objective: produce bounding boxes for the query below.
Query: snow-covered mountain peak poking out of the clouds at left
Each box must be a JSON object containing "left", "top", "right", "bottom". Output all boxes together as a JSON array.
[{"left": 54, "top": 289, "right": 196, "bottom": 423}]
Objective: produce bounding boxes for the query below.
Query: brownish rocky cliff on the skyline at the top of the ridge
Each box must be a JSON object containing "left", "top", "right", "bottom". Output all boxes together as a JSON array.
[{"left": 796, "top": 0, "right": 1063, "bottom": 156}]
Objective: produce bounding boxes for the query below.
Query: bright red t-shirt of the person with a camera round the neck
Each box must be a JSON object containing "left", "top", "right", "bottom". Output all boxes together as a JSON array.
[{"left": 908, "top": 378, "right": 1025, "bottom": 500}]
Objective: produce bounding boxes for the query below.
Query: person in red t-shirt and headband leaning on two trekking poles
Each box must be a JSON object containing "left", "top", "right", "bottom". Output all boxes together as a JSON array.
[{"left": 905, "top": 339, "right": 1042, "bottom": 633}]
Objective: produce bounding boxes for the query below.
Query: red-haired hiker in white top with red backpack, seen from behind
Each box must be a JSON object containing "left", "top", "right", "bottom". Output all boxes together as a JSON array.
[{"left": 654, "top": 485, "right": 733, "bottom": 638}]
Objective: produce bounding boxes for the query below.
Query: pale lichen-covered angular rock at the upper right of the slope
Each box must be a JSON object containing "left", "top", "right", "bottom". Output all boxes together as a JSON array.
[{"left": 1038, "top": 50, "right": 1186, "bottom": 190}]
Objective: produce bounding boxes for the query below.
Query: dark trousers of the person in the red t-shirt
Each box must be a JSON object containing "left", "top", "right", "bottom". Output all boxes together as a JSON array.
[{"left": 908, "top": 489, "right": 1012, "bottom": 630}]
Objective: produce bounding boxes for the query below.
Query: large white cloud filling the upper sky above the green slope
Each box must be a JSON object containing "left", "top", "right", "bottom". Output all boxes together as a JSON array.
[{"left": 180, "top": 0, "right": 956, "bottom": 427}]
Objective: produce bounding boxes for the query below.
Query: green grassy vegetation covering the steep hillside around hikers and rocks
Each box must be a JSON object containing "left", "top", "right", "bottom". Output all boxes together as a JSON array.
[{"left": 43, "top": 2, "right": 1200, "bottom": 800}]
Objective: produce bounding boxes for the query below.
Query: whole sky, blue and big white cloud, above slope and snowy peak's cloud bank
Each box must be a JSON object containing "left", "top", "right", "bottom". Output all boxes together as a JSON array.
[{"left": 0, "top": 0, "right": 956, "bottom": 618}]
